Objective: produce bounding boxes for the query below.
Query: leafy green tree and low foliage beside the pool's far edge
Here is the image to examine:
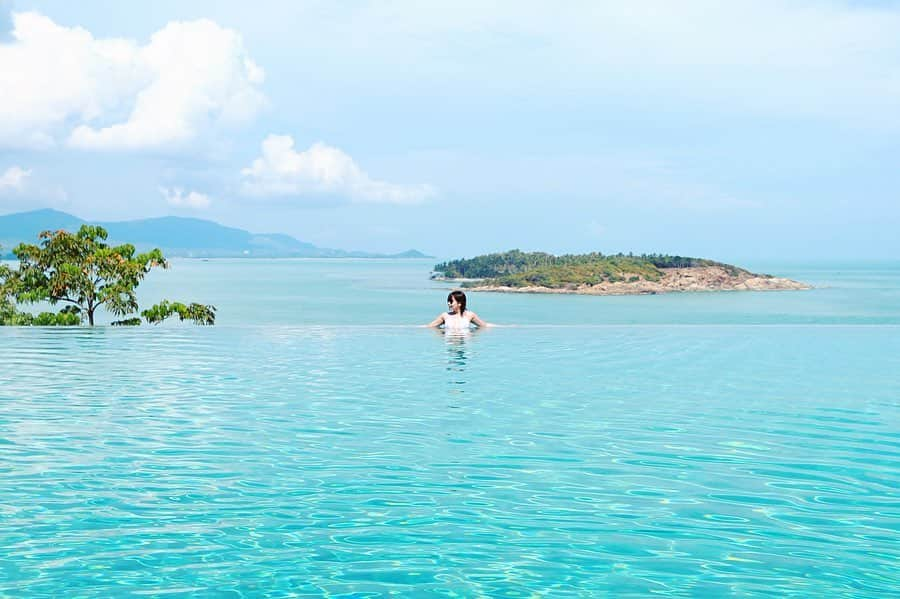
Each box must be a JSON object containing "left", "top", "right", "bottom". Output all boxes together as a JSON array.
[{"left": 0, "top": 225, "right": 216, "bottom": 326}]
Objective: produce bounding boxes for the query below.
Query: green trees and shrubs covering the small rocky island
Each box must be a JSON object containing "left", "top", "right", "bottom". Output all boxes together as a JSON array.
[{"left": 434, "top": 250, "right": 743, "bottom": 288}]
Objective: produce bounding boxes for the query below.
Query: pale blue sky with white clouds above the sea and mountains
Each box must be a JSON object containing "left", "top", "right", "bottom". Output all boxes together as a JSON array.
[{"left": 0, "top": 0, "right": 900, "bottom": 260}]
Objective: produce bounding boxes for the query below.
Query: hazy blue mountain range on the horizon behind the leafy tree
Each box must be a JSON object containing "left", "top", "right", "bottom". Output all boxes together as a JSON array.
[{"left": 0, "top": 209, "right": 431, "bottom": 258}]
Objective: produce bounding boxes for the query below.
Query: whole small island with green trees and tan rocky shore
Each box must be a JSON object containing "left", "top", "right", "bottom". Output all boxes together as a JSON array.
[{"left": 431, "top": 250, "right": 811, "bottom": 295}]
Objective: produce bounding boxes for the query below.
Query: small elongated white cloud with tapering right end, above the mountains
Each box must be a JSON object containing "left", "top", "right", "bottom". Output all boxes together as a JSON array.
[{"left": 241, "top": 135, "right": 436, "bottom": 204}]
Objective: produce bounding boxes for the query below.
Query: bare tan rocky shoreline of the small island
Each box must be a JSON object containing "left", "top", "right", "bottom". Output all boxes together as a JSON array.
[{"left": 458, "top": 266, "right": 812, "bottom": 295}]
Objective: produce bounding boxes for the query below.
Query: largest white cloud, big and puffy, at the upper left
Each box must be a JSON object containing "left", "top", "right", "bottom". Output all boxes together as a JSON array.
[{"left": 0, "top": 12, "right": 265, "bottom": 149}]
